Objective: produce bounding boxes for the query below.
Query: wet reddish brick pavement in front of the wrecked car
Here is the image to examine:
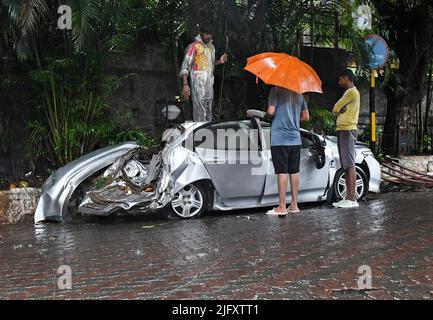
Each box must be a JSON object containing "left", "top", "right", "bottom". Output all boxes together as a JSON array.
[{"left": 0, "top": 191, "right": 433, "bottom": 299}]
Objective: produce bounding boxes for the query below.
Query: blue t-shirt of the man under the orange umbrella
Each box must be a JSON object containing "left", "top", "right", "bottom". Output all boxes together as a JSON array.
[{"left": 268, "top": 87, "right": 307, "bottom": 146}]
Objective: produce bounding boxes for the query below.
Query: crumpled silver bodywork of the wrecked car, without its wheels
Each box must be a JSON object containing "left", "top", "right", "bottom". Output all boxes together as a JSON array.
[{"left": 35, "top": 118, "right": 381, "bottom": 223}]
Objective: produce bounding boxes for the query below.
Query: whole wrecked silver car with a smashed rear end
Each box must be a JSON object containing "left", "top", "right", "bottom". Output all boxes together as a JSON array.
[{"left": 35, "top": 118, "right": 381, "bottom": 223}]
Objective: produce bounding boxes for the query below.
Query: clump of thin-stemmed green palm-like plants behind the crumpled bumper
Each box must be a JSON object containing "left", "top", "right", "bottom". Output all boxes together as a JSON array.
[{"left": 29, "top": 57, "right": 120, "bottom": 165}]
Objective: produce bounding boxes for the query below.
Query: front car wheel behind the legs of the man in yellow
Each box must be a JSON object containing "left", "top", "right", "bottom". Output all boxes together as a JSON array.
[{"left": 332, "top": 167, "right": 368, "bottom": 201}]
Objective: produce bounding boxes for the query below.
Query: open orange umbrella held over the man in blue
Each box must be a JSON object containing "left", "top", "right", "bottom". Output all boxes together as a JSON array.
[{"left": 244, "top": 52, "right": 323, "bottom": 93}]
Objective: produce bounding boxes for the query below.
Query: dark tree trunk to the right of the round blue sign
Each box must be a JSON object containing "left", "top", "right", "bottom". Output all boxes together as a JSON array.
[{"left": 374, "top": 0, "right": 433, "bottom": 155}]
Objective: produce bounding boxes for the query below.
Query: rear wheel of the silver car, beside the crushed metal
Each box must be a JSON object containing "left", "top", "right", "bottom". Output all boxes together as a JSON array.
[{"left": 168, "top": 183, "right": 208, "bottom": 219}]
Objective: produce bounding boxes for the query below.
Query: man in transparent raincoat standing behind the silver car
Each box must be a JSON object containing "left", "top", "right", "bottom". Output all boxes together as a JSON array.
[{"left": 180, "top": 25, "right": 227, "bottom": 122}]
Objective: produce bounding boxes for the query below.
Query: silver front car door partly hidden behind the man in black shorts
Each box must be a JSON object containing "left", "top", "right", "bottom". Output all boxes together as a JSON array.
[{"left": 261, "top": 123, "right": 329, "bottom": 205}]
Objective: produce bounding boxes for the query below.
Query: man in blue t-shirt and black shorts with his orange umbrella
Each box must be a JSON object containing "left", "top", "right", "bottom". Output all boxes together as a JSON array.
[{"left": 245, "top": 53, "right": 322, "bottom": 216}]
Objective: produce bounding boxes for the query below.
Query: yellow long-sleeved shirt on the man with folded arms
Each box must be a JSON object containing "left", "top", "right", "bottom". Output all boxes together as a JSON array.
[{"left": 332, "top": 87, "right": 361, "bottom": 131}]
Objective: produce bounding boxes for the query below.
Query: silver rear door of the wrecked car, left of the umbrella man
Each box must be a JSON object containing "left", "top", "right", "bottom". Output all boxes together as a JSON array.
[{"left": 195, "top": 121, "right": 266, "bottom": 206}]
